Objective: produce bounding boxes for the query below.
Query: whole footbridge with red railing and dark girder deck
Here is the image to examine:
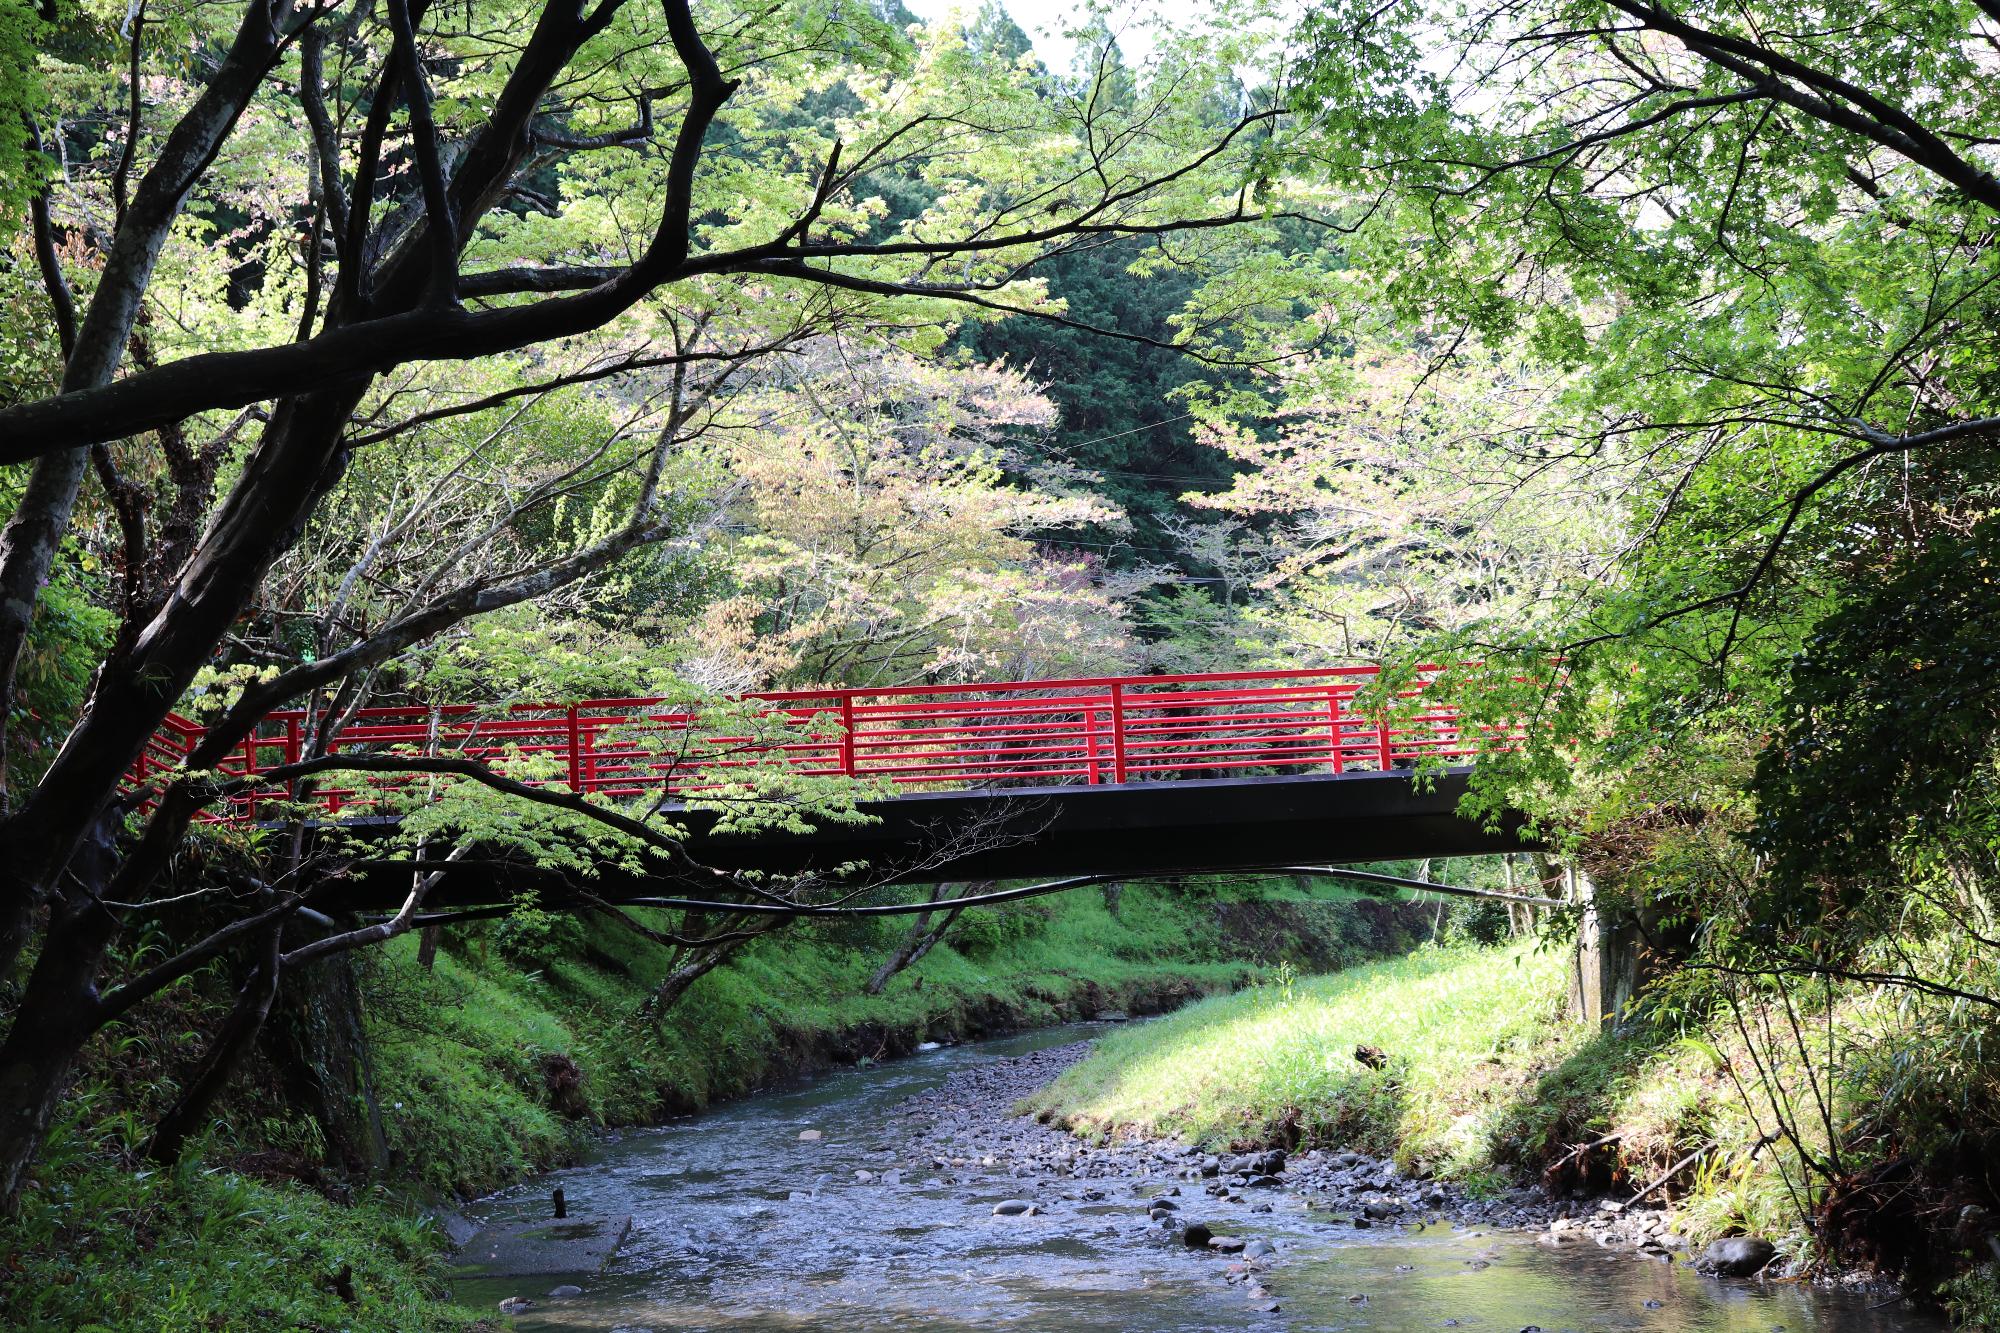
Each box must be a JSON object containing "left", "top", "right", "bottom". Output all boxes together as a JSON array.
[{"left": 132, "top": 667, "right": 1520, "bottom": 892}]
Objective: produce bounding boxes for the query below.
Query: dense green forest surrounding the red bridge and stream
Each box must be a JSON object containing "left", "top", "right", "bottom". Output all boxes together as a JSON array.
[{"left": 0, "top": 0, "right": 2000, "bottom": 1327}]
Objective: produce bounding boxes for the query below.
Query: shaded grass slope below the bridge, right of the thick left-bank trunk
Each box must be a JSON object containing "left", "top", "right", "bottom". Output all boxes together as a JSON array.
[{"left": 366, "top": 883, "right": 1408, "bottom": 1195}]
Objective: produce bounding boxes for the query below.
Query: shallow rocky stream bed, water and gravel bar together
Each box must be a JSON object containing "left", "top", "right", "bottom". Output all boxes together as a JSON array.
[{"left": 460, "top": 1029, "right": 1936, "bottom": 1333}]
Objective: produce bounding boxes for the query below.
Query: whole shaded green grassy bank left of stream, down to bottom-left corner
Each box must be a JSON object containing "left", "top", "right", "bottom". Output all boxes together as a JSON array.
[{"left": 0, "top": 881, "right": 1422, "bottom": 1331}]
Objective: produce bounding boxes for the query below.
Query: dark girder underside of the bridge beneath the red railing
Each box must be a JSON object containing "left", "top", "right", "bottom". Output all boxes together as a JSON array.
[{"left": 328, "top": 769, "right": 1532, "bottom": 907}]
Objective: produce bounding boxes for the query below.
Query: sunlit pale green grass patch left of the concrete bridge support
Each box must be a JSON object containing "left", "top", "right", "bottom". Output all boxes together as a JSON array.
[{"left": 1030, "top": 947, "right": 1574, "bottom": 1173}]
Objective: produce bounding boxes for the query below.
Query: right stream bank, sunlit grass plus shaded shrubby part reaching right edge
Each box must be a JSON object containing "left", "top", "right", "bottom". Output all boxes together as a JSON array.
[{"left": 1030, "top": 945, "right": 2000, "bottom": 1327}]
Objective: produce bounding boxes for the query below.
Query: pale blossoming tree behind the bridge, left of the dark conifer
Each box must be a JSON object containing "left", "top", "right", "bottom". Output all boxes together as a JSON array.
[{"left": 690, "top": 342, "right": 1132, "bottom": 691}]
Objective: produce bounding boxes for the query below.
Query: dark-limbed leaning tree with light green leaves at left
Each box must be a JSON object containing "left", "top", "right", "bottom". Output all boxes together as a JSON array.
[{"left": 0, "top": 0, "right": 1312, "bottom": 1199}]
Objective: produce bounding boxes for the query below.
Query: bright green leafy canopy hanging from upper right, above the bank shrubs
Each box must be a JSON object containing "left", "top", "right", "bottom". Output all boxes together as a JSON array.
[{"left": 1302, "top": 0, "right": 2000, "bottom": 844}]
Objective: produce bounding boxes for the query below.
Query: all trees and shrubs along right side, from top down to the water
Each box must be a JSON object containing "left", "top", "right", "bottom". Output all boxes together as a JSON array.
[{"left": 1278, "top": 0, "right": 2000, "bottom": 1265}]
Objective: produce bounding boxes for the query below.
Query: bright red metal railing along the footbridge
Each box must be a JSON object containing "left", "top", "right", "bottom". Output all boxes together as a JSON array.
[{"left": 132, "top": 667, "right": 1518, "bottom": 819}]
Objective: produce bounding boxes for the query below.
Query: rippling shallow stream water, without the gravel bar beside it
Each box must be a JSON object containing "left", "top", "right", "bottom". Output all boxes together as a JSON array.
[{"left": 458, "top": 1027, "right": 1942, "bottom": 1333}]
